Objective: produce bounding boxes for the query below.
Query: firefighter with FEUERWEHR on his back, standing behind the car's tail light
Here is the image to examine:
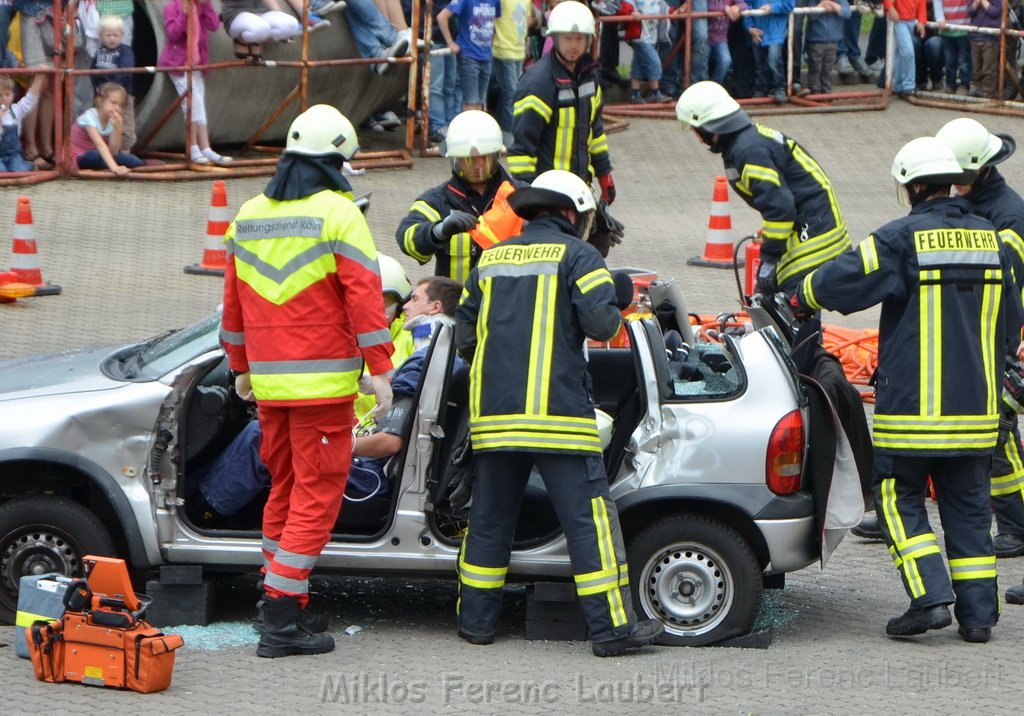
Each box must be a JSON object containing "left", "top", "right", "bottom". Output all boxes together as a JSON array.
[{"left": 793, "top": 137, "right": 1021, "bottom": 642}]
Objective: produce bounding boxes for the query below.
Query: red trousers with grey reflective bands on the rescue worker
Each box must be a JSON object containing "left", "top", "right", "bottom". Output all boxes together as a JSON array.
[{"left": 259, "top": 403, "right": 352, "bottom": 606}]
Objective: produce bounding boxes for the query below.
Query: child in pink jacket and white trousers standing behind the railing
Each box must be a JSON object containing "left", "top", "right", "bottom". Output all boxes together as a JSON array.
[{"left": 160, "top": 0, "right": 231, "bottom": 164}]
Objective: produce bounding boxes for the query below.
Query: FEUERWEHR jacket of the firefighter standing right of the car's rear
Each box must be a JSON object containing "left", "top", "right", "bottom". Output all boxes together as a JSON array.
[{"left": 799, "top": 198, "right": 1021, "bottom": 455}]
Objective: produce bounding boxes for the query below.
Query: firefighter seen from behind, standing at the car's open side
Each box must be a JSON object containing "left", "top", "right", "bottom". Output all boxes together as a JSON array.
[{"left": 456, "top": 170, "right": 662, "bottom": 657}]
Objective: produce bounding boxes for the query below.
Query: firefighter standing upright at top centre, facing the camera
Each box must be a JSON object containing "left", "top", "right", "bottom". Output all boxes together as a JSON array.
[{"left": 508, "top": 0, "right": 615, "bottom": 204}]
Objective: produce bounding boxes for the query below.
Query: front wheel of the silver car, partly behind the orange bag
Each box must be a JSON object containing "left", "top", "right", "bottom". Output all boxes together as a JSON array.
[{"left": 0, "top": 497, "right": 114, "bottom": 623}]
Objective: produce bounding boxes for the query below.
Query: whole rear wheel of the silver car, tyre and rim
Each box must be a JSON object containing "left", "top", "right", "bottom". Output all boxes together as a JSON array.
[{"left": 627, "top": 514, "right": 762, "bottom": 646}]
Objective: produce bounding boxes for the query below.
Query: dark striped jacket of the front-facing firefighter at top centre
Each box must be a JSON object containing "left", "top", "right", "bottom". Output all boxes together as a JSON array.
[{"left": 508, "top": 52, "right": 611, "bottom": 183}]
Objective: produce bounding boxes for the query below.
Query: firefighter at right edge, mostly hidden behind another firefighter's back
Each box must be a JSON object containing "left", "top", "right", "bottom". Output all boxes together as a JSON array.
[{"left": 935, "top": 117, "right": 1024, "bottom": 561}]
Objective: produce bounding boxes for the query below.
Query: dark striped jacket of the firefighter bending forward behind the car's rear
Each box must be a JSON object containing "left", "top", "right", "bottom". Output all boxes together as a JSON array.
[{"left": 722, "top": 124, "right": 850, "bottom": 286}]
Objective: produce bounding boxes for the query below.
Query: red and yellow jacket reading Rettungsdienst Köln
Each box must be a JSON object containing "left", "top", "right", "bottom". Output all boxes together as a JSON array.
[{"left": 221, "top": 191, "right": 393, "bottom": 406}]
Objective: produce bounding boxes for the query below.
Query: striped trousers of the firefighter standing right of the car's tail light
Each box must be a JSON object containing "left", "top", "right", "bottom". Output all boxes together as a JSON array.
[{"left": 873, "top": 454, "right": 999, "bottom": 628}]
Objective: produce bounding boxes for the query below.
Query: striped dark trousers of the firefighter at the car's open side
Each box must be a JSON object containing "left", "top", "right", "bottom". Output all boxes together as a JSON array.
[{"left": 458, "top": 451, "right": 636, "bottom": 641}]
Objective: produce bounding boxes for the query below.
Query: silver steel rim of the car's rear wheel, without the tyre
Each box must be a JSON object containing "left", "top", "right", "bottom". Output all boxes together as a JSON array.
[{"left": 639, "top": 543, "right": 735, "bottom": 636}]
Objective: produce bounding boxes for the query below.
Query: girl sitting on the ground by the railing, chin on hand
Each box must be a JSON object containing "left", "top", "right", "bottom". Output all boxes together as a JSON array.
[{"left": 71, "top": 82, "right": 145, "bottom": 176}]
